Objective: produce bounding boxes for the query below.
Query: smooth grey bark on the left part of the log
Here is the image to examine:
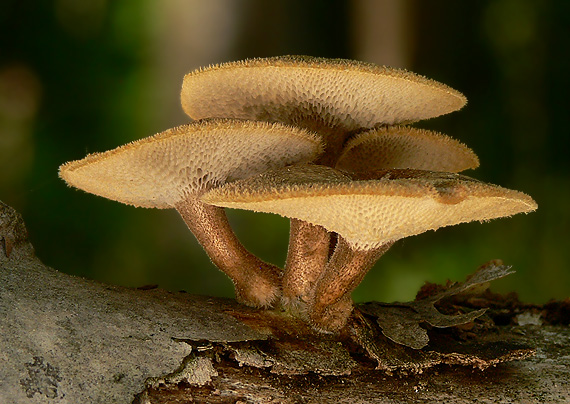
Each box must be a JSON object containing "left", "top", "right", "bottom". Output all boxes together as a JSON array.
[{"left": 0, "top": 205, "right": 264, "bottom": 403}]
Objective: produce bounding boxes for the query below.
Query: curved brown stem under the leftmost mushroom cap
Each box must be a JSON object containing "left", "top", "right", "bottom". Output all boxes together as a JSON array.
[{"left": 175, "top": 196, "right": 281, "bottom": 307}]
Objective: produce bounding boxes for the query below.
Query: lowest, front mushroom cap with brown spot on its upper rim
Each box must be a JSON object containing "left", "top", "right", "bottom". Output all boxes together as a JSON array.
[{"left": 202, "top": 165, "right": 537, "bottom": 250}]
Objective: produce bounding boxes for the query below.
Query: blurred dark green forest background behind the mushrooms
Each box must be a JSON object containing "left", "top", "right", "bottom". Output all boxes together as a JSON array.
[{"left": 0, "top": 0, "right": 570, "bottom": 303}]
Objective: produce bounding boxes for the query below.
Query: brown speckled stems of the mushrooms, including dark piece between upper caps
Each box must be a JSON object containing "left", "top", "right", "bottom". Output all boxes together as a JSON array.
[{"left": 176, "top": 130, "right": 391, "bottom": 332}]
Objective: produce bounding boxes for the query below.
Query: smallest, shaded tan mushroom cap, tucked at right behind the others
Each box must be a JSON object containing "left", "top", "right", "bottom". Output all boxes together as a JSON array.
[{"left": 336, "top": 126, "right": 479, "bottom": 173}]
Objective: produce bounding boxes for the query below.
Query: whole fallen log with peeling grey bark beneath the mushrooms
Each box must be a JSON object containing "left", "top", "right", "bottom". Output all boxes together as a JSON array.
[{"left": 0, "top": 204, "right": 570, "bottom": 403}]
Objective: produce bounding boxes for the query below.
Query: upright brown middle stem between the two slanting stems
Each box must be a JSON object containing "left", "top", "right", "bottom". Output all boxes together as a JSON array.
[{"left": 282, "top": 219, "right": 330, "bottom": 306}]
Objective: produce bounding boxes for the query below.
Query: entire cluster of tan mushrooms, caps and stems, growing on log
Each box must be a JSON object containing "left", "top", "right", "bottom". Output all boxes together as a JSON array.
[{"left": 60, "top": 56, "right": 537, "bottom": 332}]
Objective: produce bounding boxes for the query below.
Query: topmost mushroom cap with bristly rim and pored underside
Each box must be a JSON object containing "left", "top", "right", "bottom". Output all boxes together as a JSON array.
[{"left": 181, "top": 56, "right": 466, "bottom": 132}]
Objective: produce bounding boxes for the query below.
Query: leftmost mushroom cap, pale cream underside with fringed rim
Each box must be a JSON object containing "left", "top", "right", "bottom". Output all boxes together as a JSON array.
[{"left": 59, "top": 119, "right": 322, "bottom": 209}]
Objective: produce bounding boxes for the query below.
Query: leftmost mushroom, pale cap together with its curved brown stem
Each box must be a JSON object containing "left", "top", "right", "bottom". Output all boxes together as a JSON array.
[{"left": 59, "top": 119, "right": 322, "bottom": 307}]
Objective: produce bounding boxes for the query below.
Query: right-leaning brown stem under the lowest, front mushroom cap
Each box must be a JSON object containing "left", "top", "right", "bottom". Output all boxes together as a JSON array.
[{"left": 309, "top": 235, "right": 394, "bottom": 332}]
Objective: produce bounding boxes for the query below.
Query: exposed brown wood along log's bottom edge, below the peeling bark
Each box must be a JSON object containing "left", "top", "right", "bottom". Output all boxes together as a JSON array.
[{"left": 140, "top": 326, "right": 570, "bottom": 404}]
